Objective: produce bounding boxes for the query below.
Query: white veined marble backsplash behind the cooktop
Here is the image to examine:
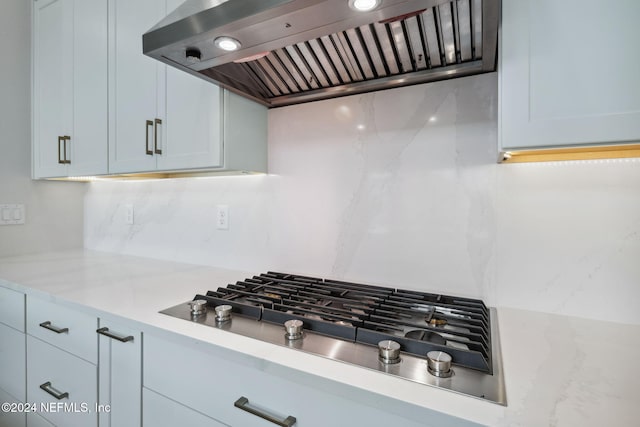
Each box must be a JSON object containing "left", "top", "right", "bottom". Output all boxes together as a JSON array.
[{"left": 85, "top": 73, "right": 640, "bottom": 324}]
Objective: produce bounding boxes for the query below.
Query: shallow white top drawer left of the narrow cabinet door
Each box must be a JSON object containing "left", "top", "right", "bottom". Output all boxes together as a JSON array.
[{"left": 27, "top": 297, "right": 98, "bottom": 364}]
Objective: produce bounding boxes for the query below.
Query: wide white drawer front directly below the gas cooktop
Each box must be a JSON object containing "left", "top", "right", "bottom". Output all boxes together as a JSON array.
[{"left": 143, "top": 335, "right": 430, "bottom": 427}]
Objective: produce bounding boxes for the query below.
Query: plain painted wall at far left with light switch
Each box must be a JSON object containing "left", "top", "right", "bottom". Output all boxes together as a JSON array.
[{"left": 0, "top": 0, "right": 86, "bottom": 256}]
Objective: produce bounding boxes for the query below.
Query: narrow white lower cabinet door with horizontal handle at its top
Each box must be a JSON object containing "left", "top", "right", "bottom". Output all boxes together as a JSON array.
[{"left": 98, "top": 319, "right": 142, "bottom": 427}]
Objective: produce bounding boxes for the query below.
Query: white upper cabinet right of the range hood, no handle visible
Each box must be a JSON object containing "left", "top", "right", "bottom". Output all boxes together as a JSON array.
[{"left": 500, "top": 0, "right": 640, "bottom": 150}]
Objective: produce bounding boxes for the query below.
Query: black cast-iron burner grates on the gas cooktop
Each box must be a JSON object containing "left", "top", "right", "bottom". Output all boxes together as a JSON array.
[{"left": 189, "top": 272, "right": 493, "bottom": 374}]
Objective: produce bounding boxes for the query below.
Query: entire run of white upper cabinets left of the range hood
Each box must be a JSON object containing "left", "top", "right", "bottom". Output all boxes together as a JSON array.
[{"left": 32, "top": 0, "right": 267, "bottom": 178}]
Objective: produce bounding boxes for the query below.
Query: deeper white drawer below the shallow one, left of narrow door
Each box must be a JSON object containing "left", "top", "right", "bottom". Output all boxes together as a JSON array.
[{"left": 27, "top": 332, "right": 98, "bottom": 427}]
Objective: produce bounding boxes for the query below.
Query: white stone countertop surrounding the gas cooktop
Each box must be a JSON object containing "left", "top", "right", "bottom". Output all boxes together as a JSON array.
[{"left": 0, "top": 250, "right": 640, "bottom": 427}]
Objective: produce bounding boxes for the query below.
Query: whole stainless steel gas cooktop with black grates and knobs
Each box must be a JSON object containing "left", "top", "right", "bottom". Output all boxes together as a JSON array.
[{"left": 161, "top": 272, "right": 506, "bottom": 405}]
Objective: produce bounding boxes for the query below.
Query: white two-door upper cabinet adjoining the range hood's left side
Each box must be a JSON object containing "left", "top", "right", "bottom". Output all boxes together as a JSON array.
[{"left": 109, "top": 0, "right": 260, "bottom": 174}]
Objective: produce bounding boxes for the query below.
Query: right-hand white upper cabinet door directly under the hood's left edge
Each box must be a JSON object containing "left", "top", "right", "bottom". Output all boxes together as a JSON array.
[{"left": 158, "top": 67, "right": 222, "bottom": 170}]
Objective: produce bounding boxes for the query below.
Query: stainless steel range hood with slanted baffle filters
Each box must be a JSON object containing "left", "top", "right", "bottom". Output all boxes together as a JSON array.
[{"left": 143, "top": 0, "right": 500, "bottom": 107}]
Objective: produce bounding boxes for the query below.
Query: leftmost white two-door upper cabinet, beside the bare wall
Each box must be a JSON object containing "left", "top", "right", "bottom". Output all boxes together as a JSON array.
[{"left": 33, "top": 0, "right": 107, "bottom": 178}]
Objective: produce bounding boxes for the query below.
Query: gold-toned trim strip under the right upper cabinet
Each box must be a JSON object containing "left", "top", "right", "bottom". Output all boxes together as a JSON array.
[{"left": 498, "top": 144, "right": 640, "bottom": 163}]
